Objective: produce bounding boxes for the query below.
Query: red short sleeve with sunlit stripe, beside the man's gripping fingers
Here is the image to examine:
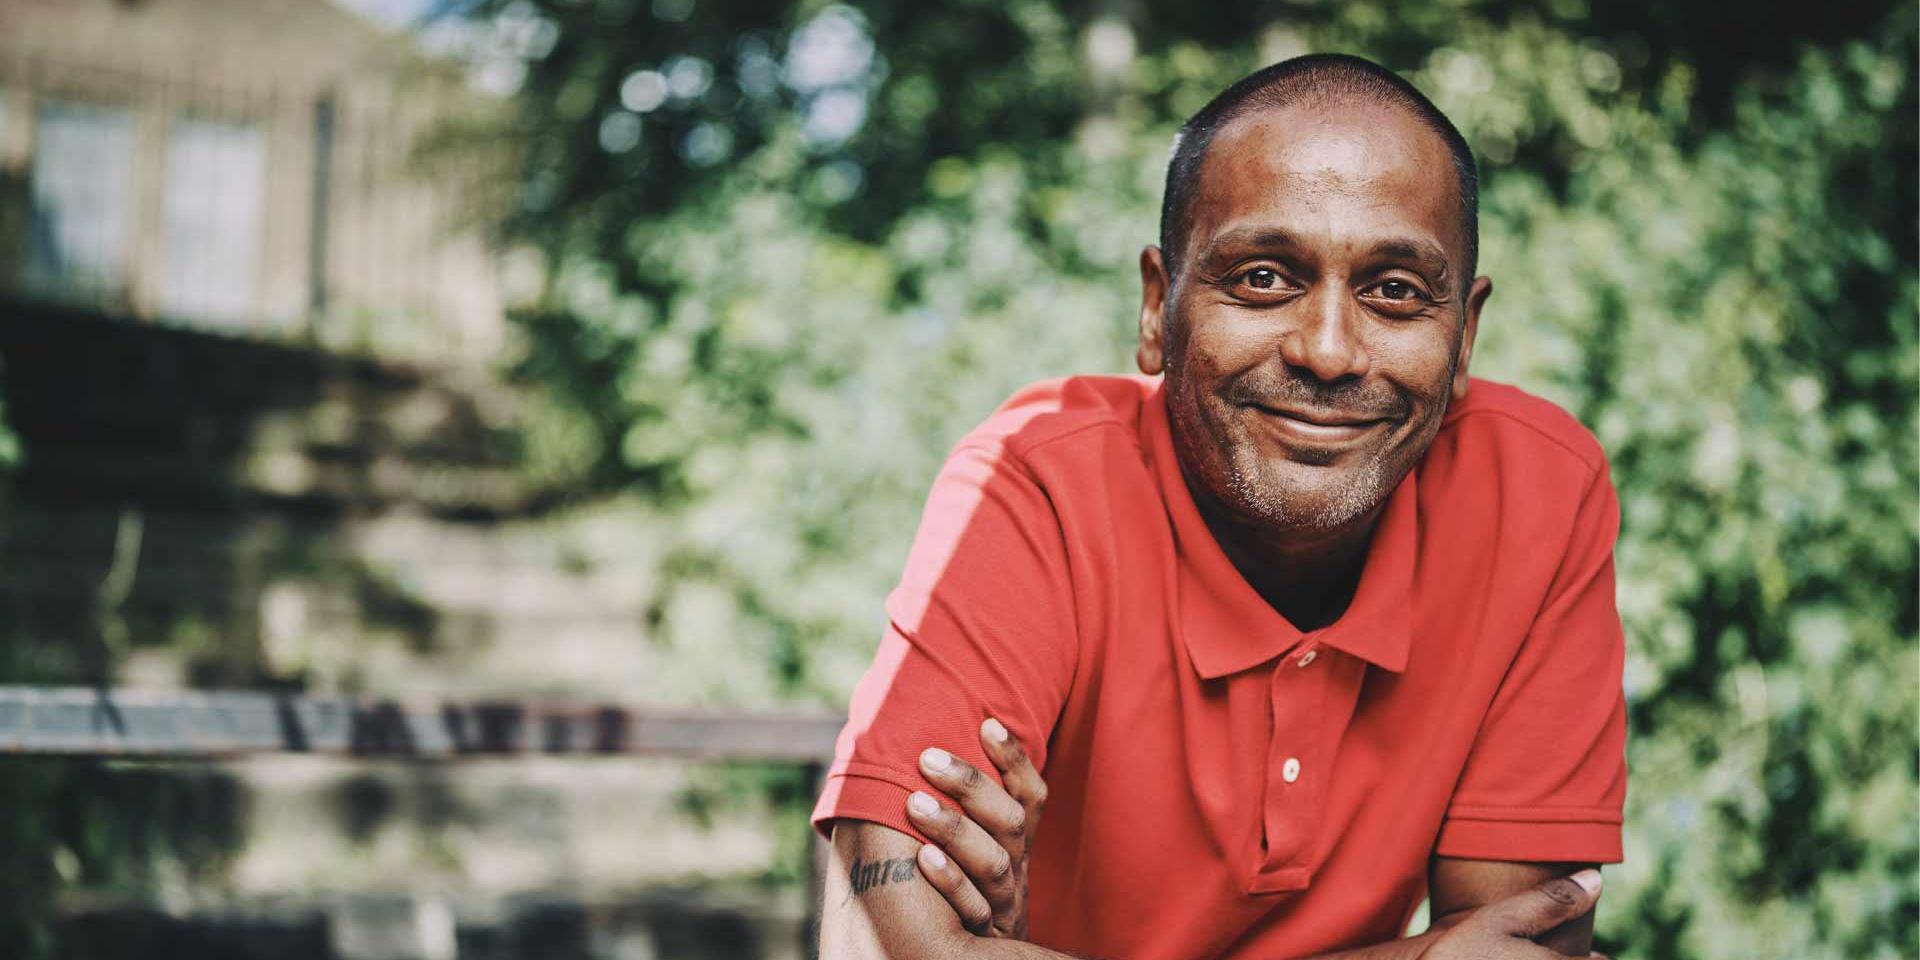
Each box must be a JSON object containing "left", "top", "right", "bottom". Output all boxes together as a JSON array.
[{"left": 812, "top": 442, "right": 1075, "bottom": 839}]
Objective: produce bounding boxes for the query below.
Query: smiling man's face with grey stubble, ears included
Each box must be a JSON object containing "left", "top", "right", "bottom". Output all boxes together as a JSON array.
[{"left": 1139, "top": 102, "right": 1492, "bottom": 536}]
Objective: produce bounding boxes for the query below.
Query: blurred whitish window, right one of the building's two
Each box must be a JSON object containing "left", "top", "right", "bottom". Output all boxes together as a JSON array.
[{"left": 159, "top": 121, "right": 267, "bottom": 326}]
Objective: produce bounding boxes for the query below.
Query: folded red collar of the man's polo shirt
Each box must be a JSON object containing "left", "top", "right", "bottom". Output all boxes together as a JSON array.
[{"left": 1142, "top": 380, "right": 1419, "bottom": 680}]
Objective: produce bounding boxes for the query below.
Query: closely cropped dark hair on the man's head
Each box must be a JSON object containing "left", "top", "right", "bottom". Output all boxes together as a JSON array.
[{"left": 1160, "top": 54, "right": 1480, "bottom": 282}]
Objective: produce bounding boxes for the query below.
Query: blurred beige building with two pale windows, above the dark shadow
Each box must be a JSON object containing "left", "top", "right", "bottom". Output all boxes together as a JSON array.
[{"left": 0, "top": 0, "right": 503, "bottom": 363}]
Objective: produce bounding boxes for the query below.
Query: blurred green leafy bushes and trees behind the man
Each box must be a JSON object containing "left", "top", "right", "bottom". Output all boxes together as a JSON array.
[{"left": 444, "top": 0, "right": 1920, "bottom": 960}]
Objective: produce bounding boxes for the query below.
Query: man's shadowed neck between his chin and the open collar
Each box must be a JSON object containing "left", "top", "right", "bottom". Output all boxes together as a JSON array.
[{"left": 1188, "top": 484, "right": 1386, "bottom": 632}]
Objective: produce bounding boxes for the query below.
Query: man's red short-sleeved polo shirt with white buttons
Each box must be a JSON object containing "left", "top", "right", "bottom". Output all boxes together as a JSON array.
[{"left": 814, "top": 376, "right": 1626, "bottom": 960}]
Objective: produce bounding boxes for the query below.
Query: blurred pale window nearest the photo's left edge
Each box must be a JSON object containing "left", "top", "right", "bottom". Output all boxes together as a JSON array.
[{"left": 27, "top": 102, "right": 134, "bottom": 303}]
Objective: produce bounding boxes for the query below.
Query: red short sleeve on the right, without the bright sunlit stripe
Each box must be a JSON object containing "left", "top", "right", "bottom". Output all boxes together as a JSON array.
[{"left": 1434, "top": 458, "right": 1626, "bottom": 864}]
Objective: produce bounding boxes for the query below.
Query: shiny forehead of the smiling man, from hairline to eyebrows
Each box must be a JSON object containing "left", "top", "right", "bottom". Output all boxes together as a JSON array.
[{"left": 1188, "top": 100, "right": 1465, "bottom": 259}]
